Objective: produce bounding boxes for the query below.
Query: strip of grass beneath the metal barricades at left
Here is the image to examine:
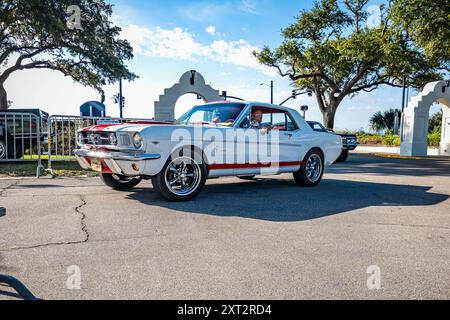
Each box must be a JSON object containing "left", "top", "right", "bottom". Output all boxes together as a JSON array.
[{"left": 0, "top": 161, "right": 98, "bottom": 178}]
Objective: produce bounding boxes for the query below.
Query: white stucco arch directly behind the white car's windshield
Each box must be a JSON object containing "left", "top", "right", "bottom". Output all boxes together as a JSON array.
[{"left": 155, "top": 70, "right": 223, "bottom": 121}]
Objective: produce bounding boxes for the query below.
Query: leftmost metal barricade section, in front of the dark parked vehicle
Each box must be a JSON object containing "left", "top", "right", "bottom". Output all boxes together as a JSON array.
[{"left": 0, "top": 112, "right": 45, "bottom": 176}]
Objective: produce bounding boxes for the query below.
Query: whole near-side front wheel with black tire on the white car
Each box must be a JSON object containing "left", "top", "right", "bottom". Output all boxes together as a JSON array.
[{"left": 152, "top": 153, "right": 208, "bottom": 202}]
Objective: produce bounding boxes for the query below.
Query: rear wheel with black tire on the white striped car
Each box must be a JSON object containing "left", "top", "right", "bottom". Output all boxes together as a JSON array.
[{"left": 294, "top": 149, "right": 325, "bottom": 187}]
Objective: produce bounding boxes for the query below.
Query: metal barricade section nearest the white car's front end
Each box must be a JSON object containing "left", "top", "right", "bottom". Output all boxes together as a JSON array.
[{"left": 47, "top": 115, "right": 151, "bottom": 172}]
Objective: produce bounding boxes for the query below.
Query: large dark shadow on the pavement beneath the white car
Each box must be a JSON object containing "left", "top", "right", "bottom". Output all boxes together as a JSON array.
[{"left": 128, "top": 179, "right": 449, "bottom": 222}]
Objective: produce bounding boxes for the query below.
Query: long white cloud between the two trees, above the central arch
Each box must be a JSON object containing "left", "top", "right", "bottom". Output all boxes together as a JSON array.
[{"left": 122, "top": 25, "right": 276, "bottom": 77}]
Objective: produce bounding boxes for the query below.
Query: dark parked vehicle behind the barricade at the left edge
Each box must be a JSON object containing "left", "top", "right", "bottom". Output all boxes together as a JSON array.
[{"left": 0, "top": 109, "right": 49, "bottom": 159}]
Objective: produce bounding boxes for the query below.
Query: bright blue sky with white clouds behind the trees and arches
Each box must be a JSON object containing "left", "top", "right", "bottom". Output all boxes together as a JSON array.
[{"left": 6, "top": 0, "right": 434, "bottom": 130}]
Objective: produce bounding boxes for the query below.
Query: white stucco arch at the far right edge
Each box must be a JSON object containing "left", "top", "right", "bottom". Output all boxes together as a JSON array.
[{"left": 400, "top": 81, "right": 450, "bottom": 156}]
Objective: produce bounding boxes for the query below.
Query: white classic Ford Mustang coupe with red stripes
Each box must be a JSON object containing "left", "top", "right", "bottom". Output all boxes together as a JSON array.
[{"left": 74, "top": 101, "right": 342, "bottom": 201}]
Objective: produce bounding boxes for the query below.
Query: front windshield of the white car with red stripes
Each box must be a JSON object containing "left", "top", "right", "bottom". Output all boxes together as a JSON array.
[{"left": 178, "top": 103, "right": 245, "bottom": 127}]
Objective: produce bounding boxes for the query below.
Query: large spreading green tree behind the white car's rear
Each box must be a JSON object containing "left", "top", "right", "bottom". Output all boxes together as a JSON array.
[{"left": 255, "top": 0, "right": 449, "bottom": 128}]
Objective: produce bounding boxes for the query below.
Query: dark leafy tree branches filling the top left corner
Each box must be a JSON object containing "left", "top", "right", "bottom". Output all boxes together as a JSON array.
[{"left": 0, "top": 0, "right": 136, "bottom": 107}]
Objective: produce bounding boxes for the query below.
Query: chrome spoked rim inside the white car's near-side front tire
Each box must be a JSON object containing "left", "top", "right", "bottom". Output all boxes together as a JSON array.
[{"left": 164, "top": 157, "right": 202, "bottom": 196}]
